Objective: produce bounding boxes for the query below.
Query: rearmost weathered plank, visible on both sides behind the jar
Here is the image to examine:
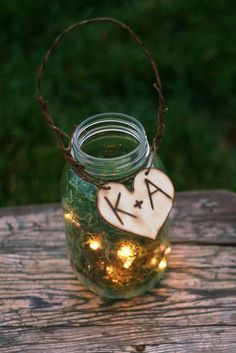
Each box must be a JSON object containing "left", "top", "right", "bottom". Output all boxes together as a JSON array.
[{"left": 0, "top": 191, "right": 236, "bottom": 245}]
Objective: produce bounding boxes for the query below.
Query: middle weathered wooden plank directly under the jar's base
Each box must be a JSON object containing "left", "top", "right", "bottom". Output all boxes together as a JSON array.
[{"left": 0, "top": 243, "right": 236, "bottom": 326}]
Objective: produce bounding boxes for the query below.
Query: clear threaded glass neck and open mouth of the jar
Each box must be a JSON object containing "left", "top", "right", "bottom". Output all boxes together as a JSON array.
[{"left": 71, "top": 113, "right": 150, "bottom": 181}]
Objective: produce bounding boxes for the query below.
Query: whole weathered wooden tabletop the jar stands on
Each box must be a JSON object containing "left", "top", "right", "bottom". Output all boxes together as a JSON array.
[{"left": 0, "top": 191, "right": 236, "bottom": 353}]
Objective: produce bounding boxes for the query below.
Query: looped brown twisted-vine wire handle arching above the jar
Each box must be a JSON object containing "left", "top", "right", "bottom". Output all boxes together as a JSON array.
[{"left": 37, "top": 17, "right": 166, "bottom": 187}]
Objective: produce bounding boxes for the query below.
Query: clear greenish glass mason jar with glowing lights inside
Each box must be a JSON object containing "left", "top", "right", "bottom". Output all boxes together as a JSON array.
[{"left": 62, "top": 113, "right": 170, "bottom": 299}]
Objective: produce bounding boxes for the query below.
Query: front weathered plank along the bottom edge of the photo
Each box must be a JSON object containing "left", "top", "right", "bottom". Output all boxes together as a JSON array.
[{"left": 0, "top": 322, "right": 236, "bottom": 353}]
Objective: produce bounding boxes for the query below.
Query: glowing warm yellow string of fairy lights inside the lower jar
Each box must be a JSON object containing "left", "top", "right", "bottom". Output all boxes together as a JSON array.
[{"left": 64, "top": 209, "right": 171, "bottom": 293}]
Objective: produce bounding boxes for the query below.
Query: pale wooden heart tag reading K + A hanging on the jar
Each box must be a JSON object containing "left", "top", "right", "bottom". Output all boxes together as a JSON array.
[{"left": 97, "top": 168, "right": 174, "bottom": 239}]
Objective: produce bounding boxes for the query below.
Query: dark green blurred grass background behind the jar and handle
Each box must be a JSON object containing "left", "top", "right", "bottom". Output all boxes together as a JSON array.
[{"left": 0, "top": 0, "right": 236, "bottom": 206}]
